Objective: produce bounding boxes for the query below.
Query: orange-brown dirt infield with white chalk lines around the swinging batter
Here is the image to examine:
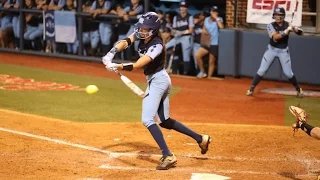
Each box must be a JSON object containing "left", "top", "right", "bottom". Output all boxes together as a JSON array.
[{"left": 0, "top": 53, "right": 320, "bottom": 180}]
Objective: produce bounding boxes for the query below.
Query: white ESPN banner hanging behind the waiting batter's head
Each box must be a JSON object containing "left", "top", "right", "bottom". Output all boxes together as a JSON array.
[{"left": 247, "top": 0, "right": 302, "bottom": 26}]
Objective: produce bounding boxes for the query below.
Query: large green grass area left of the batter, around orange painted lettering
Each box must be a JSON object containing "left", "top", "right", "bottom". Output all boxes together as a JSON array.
[{"left": 0, "top": 64, "right": 179, "bottom": 122}]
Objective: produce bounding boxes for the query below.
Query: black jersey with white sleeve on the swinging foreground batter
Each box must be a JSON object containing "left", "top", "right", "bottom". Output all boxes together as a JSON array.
[{"left": 138, "top": 37, "right": 165, "bottom": 75}]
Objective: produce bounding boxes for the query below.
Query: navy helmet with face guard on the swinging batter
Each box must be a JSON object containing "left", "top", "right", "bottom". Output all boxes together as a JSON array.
[{"left": 134, "top": 12, "right": 161, "bottom": 39}]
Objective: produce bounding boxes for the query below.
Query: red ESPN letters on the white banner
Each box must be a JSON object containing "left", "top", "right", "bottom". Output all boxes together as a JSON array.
[{"left": 251, "top": 0, "right": 298, "bottom": 11}]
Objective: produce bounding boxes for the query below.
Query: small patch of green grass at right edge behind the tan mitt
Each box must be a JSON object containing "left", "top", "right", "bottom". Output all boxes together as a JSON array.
[{"left": 285, "top": 96, "right": 320, "bottom": 127}]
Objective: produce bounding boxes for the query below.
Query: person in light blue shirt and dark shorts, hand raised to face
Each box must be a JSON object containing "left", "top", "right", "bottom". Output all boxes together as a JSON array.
[{"left": 196, "top": 6, "right": 224, "bottom": 78}]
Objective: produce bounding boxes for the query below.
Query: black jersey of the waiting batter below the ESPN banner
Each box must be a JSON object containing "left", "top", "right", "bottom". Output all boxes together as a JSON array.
[{"left": 267, "top": 21, "right": 289, "bottom": 49}]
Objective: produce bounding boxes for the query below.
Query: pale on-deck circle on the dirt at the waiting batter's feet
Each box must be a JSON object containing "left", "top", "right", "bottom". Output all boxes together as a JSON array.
[{"left": 261, "top": 88, "right": 320, "bottom": 97}]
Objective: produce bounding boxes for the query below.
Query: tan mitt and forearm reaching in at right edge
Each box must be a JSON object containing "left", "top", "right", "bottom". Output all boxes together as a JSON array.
[{"left": 289, "top": 106, "right": 320, "bottom": 140}]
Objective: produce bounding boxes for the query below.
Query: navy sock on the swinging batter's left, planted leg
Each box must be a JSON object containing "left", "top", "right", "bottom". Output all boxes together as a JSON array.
[{"left": 148, "top": 124, "right": 172, "bottom": 156}]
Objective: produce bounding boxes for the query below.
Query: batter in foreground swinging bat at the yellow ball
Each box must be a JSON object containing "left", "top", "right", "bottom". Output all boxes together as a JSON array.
[{"left": 102, "top": 12, "right": 211, "bottom": 170}]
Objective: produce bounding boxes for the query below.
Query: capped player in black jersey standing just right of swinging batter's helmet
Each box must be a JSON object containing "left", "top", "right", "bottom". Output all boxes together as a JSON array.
[{"left": 166, "top": 1, "right": 194, "bottom": 74}]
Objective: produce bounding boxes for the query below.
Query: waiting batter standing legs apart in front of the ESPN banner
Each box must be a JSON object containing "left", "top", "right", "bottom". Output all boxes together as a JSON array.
[{"left": 247, "top": 8, "right": 303, "bottom": 98}]
